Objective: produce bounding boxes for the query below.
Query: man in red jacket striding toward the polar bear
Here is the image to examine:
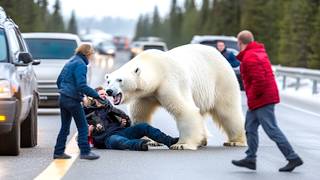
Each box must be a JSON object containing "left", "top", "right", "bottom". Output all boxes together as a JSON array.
[{"left": 232, "top": 30, "right": 303, "bottom": 172}]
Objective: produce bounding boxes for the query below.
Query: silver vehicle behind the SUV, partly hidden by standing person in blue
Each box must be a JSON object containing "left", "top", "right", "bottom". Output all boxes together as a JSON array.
[{"left": 22, "top": 33, "right": 80, "bottom": 107}]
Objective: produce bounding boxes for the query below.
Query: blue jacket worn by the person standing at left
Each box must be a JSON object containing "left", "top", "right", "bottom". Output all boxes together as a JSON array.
[{"left": 57, "top": 53, "right": 99, "bottom": 102}]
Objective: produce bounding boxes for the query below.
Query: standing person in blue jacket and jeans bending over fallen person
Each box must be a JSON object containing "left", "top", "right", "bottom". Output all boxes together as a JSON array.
[{"left": 53, "top": 44, "right": 106, "bottom": 160}]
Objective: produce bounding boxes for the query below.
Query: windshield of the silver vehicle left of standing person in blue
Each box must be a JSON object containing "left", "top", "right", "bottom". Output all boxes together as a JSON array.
[{"left": 25, "top": 38, "right": 77, "bottom": 59}]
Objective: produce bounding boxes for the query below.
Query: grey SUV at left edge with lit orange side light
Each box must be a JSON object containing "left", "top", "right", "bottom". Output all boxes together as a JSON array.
[{"left": 0, "top": 6, "right": 40, "bottom": 155}]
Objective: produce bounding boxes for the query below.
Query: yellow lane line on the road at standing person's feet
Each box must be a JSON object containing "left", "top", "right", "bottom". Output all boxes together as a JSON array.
[{"left": 35, "top": 133, "right": 79, "bottom": 180}]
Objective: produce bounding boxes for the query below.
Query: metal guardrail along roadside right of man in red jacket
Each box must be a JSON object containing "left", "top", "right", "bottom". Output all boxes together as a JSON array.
[{"left": 273, "top": 66, "right": 320, "bottom": 94}]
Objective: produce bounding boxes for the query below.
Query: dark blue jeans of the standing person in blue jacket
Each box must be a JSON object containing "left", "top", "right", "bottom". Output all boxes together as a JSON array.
[{"left": 54, "top": 95, "right": 90, "bottom": 155}]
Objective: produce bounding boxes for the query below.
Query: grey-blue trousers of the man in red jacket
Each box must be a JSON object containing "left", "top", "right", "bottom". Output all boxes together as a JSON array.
[{"left": 245, "top": 104, "right": 298, "bottom": 160}]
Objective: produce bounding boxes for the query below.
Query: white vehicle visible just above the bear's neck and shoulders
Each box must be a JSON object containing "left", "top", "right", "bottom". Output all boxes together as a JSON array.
[{"left": 130, "top": 41, "right": 168, "bottom": 59}]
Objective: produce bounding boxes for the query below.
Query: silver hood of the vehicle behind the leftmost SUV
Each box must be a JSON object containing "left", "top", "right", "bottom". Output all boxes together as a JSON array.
[{"left": 33, "top": 59, "right": 68, "bottom": 82}]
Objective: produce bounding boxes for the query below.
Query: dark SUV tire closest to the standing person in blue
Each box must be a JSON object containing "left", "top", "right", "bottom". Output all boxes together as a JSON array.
[{"left": 21, "top": 95, "right": 38, "bottom": 147}]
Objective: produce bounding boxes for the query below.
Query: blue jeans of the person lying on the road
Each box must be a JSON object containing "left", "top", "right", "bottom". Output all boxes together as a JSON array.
[{"left": 105, "top": 123, "right": 175, "bottom": 150}]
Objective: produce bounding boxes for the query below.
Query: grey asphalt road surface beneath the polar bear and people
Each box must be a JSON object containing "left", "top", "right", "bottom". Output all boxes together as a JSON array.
[{"left": 0, "top": 53, "right": 320, "bottom": 180}]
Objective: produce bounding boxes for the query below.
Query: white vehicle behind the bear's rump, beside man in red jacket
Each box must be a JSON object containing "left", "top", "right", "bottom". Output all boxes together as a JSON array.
[{"left": 191, "top": 35, "right": 244, "bottom": 90}]
